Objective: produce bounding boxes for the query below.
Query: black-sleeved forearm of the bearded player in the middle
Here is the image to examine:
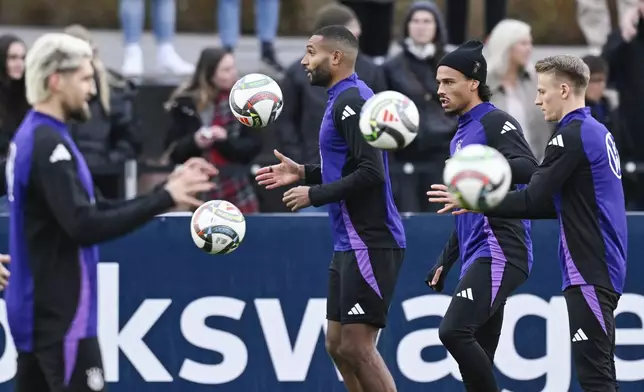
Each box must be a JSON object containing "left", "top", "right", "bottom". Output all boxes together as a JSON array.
[{"left": 309, "top": 167, "right": 385, "bottom": 207}]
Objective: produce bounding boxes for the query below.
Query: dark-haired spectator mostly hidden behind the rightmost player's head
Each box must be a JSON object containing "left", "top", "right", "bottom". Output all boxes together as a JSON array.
[{"left": 583, "top": 55, "right": 621, "bottom": 135}]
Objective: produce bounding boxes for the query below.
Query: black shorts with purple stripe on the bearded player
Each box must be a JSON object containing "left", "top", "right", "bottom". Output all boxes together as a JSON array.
[{"left": 326, "top": 249, "right": 405, "bottom": 328}]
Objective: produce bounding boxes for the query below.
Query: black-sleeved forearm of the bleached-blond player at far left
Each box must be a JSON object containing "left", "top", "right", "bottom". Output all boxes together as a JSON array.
[{"left": 61, "top": 188, "right": 174, "bottom": 245}]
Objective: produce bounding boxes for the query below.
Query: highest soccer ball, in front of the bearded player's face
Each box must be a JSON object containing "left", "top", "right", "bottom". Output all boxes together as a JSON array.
[{"left": 228, "top": 73, "right": 284, "bottom": 128}]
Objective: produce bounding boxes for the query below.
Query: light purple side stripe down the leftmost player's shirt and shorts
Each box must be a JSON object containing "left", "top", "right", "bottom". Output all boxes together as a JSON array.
[{"left": 64, "top": 251, "right": 90, "bottom": 385}]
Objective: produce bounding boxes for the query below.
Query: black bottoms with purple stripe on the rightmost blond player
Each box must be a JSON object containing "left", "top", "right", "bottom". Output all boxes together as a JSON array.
[{"left": 564, "top": 285, "right": 620, "bottom": 392}]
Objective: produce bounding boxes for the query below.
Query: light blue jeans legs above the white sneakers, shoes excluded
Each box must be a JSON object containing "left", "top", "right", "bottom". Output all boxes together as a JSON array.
[{"left": 119, "top": 0, "right": 177, "bottom": 45}]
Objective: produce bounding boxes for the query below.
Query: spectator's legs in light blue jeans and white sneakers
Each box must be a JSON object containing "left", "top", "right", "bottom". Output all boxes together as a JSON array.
[{"left": 119, "top": 0, "right": 194, "bottom": 76}]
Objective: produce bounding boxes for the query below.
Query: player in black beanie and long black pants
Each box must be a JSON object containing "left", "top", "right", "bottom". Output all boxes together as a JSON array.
[{"left": 426, "top": 41, "right": 537, "bottom": 392}]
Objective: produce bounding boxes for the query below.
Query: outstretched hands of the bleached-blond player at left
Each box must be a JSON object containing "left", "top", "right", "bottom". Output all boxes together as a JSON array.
[{"left": 165, "top": 166, "right": 215, "bottom": 208}]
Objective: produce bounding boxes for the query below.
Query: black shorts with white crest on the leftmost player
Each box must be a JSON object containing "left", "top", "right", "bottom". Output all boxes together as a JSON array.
[{"left": 15, "top": 338, "right": 107, "bottom": 392}]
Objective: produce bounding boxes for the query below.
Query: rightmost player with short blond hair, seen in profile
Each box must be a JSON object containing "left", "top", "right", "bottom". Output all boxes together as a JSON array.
[{"left": 436, "top": 55, "right": 628, "bottom": 392}]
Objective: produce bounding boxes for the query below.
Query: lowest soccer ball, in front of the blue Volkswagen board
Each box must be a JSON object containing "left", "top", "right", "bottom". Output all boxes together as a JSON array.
[{"left": 190, "top": 200, "right": 246, "bottom": 255}]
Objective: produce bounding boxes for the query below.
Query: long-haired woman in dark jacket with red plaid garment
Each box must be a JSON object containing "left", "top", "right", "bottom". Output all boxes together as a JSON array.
[{"left": 166, "top": 48, "right": 262, "bottom": 214}]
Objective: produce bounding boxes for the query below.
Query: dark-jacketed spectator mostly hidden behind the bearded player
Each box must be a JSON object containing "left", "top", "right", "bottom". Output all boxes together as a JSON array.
[{"left": 275, "top": 3, "right": 386, "bottom": 163}]
